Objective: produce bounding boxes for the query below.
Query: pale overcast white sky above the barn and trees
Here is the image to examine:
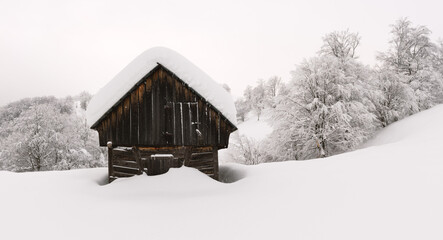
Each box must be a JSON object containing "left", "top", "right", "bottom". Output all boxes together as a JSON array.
[{"left": 0, "top": 0, "right": 443, "bottom": 106}]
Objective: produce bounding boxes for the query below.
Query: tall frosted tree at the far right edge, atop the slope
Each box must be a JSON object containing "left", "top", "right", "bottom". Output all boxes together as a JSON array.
[{"left": 378, "top": 18, "right": 443, "bottom": 111}]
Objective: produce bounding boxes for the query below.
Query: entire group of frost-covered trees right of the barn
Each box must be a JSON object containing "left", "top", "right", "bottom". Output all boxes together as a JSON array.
[{"left": 232, "top": 22, "right": 443, "bottom": 163}]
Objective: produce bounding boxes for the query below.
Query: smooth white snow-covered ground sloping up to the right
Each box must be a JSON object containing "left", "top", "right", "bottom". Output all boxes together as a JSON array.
[{"left": 0, "top": 105, "right": 443, "bottom": 240}]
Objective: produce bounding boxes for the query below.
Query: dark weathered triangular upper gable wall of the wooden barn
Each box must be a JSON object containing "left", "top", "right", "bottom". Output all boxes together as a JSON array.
[{"left": 93, "top": 65, "right": 236, "bottom": 148}]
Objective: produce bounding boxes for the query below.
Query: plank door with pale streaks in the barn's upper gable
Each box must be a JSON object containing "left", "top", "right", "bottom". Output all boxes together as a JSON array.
[{"left": 164, "top": 102, "right": 200, "bottom": 146}]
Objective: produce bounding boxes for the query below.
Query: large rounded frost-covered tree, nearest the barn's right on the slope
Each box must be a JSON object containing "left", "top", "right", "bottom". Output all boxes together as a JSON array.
[{"left": 274, "top": 55, "right": 374, "bottom": 159}]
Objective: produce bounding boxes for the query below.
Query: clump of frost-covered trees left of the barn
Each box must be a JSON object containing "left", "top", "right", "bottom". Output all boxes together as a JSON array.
[{"left": 0, "top": 94, "right": 105, "bottom": 171}]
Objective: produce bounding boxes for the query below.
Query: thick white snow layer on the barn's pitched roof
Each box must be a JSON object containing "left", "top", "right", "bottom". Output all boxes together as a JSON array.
[{"left": 87, "top": 47, "right": 237, "bottom": 126}]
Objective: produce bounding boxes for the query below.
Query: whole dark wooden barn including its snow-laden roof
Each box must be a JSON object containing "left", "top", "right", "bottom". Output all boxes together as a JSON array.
[{"left": 87, "top": 48, "right": 237, "bottom": 182}]
